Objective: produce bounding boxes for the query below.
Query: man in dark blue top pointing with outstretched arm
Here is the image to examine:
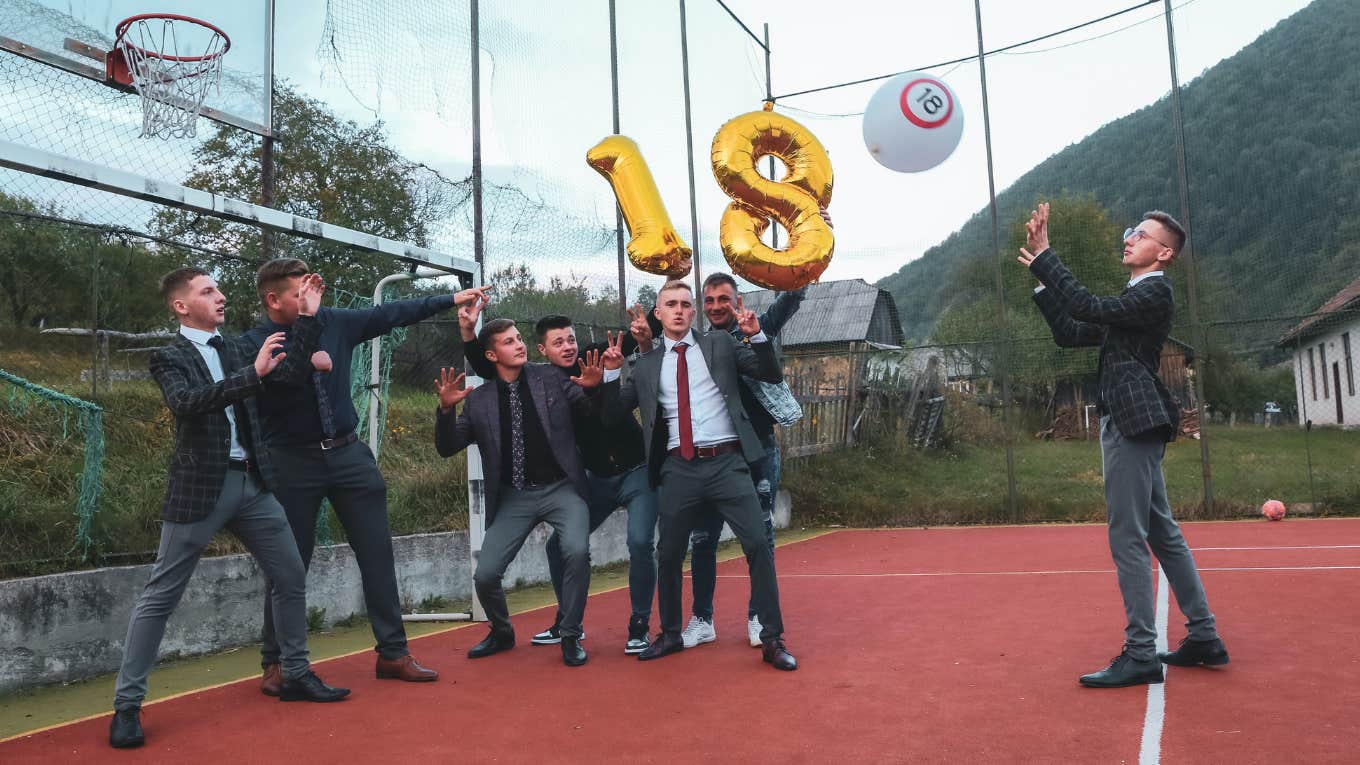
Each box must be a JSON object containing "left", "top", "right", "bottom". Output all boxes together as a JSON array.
[{"left": 246, "top": 257, "right": 484, "bottom": 696}]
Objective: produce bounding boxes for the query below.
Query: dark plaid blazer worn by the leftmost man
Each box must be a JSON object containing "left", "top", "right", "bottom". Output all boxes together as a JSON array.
[{"left": 151, "top": 317, "right": 321, "bottom": 523}]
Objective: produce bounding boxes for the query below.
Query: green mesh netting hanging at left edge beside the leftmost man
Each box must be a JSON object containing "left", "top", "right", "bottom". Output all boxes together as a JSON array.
[{"left": 0, "top": 369, "right": 103, "bottom": 559}]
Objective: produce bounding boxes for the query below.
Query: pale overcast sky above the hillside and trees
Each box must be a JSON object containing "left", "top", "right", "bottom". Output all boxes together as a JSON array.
[{"left": 0, "top": 0, "right": 1307, "bottom": 291}]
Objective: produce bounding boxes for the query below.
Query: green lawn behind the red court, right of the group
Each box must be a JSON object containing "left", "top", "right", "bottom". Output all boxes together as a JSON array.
[{"left": 783, "top": 426, "right": 1360, "bottom": 525}]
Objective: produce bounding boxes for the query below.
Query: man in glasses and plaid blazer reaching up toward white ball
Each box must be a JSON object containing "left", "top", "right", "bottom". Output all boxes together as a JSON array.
[{"left": 1019, "top": 203, "right": 1228, "bottom": 687}]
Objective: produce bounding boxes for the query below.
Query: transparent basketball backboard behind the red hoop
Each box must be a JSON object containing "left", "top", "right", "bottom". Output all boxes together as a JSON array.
[{"left": 0, "top": 0, "right": 275, "bottom": 135}]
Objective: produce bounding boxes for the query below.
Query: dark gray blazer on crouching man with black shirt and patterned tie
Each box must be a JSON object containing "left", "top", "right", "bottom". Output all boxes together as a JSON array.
[{"left": 434, "top": 363, "right": 598, "bottom": 525}]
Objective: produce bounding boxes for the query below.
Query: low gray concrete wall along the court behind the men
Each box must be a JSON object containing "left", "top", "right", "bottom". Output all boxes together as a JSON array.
[{"left": 0, "top": 491, "right": 789, "bottom": 693}]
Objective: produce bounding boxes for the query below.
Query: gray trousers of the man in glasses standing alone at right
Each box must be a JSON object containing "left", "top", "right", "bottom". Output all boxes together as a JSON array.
[{"left": 1100, "top": 417, "right": 1219, "bottom": 662}]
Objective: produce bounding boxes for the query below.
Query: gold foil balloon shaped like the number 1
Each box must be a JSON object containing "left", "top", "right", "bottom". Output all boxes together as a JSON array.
[{"left": 586, "top": 136, "right": 692, "bottom": 276}]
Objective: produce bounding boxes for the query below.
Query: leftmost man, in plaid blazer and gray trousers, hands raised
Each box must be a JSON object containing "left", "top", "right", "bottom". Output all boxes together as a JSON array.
[{"left": 109, "top": 268, "right": 350, "bottom": 749}]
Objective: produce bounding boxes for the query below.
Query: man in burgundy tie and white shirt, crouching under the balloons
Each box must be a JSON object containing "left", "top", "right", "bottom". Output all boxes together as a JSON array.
[{"left": 602, "top": 280, "right": 798, "bottom": 670}]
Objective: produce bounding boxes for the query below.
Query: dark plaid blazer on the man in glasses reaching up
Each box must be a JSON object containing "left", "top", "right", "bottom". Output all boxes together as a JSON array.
[{"left": 1030, "top": 249, "right": 1180, "bottom": 441}]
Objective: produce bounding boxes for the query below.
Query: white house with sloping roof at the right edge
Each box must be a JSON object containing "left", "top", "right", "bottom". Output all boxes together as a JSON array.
[{"left": 1278, "top": 278, "right": 1360, "bottom": 427}]
